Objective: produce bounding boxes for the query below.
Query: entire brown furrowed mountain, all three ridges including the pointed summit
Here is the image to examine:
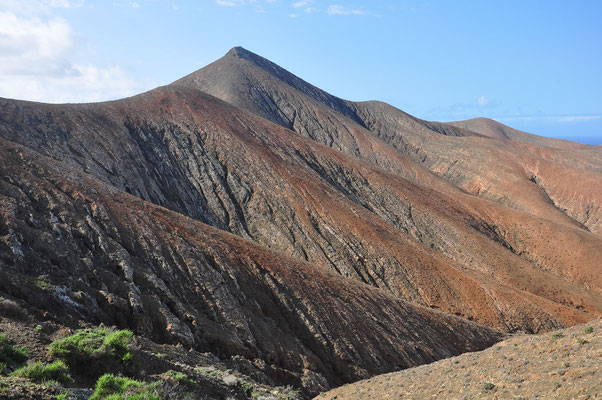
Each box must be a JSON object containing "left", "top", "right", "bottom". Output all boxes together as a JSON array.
[{"left": 0, "top": 48, "right": 602, "bottom": 393}]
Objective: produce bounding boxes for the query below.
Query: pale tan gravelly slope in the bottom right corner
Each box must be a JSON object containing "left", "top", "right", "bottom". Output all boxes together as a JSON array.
[{"left": 316, "top": 320, "right": 602, "bottom": 400}]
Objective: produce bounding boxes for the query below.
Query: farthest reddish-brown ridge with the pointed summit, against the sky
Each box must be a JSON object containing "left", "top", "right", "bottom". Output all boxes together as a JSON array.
[{"left": 173, "top": 48, "right": 602, "bottom": 236}]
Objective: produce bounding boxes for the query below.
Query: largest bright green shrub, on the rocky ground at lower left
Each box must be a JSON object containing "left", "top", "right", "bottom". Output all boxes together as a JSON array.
[{"left": 49, "top": 328, "right": 133, "bottom": 378}]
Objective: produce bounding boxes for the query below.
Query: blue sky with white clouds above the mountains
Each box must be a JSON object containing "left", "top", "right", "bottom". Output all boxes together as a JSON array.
[{"left": 0, "top": 0, "right": 602, "bottom": 144}]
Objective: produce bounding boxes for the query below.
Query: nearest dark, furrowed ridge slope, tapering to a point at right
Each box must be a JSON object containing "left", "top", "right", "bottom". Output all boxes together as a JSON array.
[{"left": 0, "top": 140, "right": 500, "bottom": 394}]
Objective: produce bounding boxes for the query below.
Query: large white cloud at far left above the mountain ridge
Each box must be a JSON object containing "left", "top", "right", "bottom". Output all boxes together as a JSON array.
[{"left": 0, "top": 9, "right": 148, "bottom": 103}]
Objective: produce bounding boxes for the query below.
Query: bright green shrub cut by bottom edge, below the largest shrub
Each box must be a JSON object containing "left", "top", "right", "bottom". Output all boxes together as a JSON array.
[{"left": 90, "top": 374, "right": 161, "bottom": 400}]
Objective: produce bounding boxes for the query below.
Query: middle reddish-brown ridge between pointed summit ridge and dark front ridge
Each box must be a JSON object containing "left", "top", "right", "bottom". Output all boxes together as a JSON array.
[{"left": 0, "top": 87, "right": 602, "bottom": 331}]
